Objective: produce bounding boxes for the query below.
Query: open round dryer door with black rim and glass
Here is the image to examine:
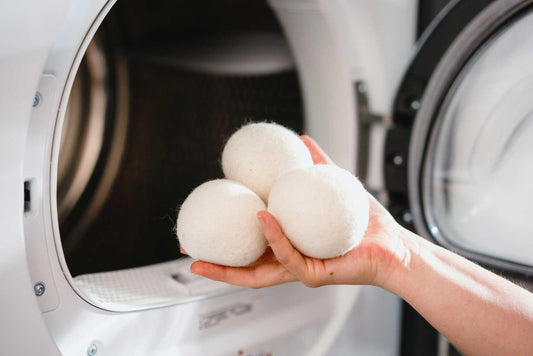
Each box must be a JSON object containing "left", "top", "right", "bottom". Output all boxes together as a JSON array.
[{"left": 385, "top": 0, "right": 533, "bottom": 354}]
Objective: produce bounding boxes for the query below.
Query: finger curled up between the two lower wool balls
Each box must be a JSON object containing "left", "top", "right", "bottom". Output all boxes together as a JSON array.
[{"left": 257, "top": 210, "right": 307, "bottom": 280}]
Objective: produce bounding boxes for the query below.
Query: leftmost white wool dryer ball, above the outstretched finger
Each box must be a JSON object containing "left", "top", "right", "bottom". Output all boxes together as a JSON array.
[{"left": 176, "top": 179, "right": 267, "bottom": 266}]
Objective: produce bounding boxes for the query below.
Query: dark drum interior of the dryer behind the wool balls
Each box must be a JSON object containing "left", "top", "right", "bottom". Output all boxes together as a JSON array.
[{"left": 57, "top": 0, "right": 303, "bottom": 276}]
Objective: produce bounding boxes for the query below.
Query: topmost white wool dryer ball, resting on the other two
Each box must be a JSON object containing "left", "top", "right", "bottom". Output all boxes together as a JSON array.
[{"left": 222, "top": 122, "right": 313, "bottom": 201}]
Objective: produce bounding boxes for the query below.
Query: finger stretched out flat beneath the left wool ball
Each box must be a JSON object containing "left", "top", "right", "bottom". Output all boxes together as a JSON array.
[{"left": 191, "top": 261, "right": 296, "bottom": 288}]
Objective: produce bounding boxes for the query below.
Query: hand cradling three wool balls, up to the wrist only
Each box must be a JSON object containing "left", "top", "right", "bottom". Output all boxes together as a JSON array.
[{"left": 181, "top": 135, "right": 408, "bottom": 288}]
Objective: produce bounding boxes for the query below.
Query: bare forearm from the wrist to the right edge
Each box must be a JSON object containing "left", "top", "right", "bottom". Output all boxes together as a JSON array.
[{"left": 383, "top": 231, "right": 533, "bottom": 355}]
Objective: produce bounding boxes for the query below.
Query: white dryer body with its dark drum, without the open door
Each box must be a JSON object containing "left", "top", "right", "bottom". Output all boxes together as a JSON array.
[{"left": 0, "top": 0, "right": 415, "bottom": 356}]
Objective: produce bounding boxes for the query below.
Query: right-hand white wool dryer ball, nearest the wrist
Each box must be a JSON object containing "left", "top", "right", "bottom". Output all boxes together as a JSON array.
[{"left": 268, "top": 164, "right": 369, "bottom": 259}]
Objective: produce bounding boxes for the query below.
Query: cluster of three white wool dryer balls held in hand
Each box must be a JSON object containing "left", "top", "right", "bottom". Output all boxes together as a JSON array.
[{"left": 177, "top": 123, "right": 369, "bottom": 266}]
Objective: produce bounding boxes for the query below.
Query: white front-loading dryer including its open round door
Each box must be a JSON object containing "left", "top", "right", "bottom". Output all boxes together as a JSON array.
[{"left": 0, "top": 0, "right": 533, "bottom": 356}]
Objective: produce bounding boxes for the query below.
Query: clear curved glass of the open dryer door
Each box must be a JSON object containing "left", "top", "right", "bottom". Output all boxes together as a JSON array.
[{"left": 423, "top": 9, "right": 533, "bottom": 265}]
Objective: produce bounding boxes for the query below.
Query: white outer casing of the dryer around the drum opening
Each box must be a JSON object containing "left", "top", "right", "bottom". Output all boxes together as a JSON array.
[{"left": 0, "top": 0, "right": 416, "bottom": 356}]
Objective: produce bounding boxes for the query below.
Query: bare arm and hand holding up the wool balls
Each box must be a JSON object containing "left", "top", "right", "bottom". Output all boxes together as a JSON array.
[{"left": 182, "top": 136, "right": 533, "bottom": 355}]
